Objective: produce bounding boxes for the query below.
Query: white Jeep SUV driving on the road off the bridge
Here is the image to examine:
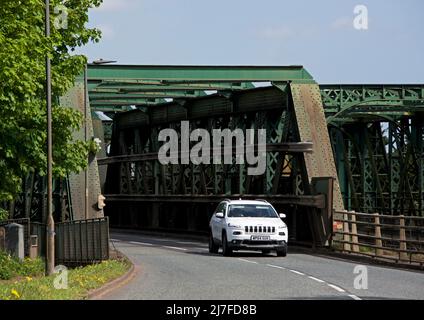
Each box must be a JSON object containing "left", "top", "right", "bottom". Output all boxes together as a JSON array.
[{"left": 209, "top": 200, "right": 288, "bottom": 257}]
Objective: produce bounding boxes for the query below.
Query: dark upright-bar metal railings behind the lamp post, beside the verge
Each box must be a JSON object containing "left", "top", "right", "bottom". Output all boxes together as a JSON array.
[{"left": 0, "top": 217, "right": 109, "bottom": 266}]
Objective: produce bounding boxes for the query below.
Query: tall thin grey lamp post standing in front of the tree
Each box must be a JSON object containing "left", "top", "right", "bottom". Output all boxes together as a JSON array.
[{"left": 45, "top": 0, "right": 55, "bottom": 275}]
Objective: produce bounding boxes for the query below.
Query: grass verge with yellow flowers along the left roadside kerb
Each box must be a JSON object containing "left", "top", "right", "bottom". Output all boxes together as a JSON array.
[{"left": 0, "top": 252, "right": 131, "bottom": 300}]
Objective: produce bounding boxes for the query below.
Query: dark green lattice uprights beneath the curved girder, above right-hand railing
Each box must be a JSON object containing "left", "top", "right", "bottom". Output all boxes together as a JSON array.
[{"left": 330, "top": 116, "right": 424, "bottom": 216}]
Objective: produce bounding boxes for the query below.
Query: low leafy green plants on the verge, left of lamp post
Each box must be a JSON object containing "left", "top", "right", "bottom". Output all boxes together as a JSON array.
[{"left": 0, "top": 251, "right": 44, "bottom": 280}]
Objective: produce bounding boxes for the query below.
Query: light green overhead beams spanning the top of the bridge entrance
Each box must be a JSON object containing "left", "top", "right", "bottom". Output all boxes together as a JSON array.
[{"left": 88, "top": 64, "right": 314, "bottom": 111}]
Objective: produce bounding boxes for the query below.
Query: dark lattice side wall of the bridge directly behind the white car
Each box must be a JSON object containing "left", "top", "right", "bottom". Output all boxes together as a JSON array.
[{"left": 99, "top": 86, "right": 331, "bottom": 244}]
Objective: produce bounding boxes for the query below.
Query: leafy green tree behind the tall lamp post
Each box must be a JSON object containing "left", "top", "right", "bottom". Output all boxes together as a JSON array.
[{"left": 0, "top": 0, "right": 102, "bottom": 201}]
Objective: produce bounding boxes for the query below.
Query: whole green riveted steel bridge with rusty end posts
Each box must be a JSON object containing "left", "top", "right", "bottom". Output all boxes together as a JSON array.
[{"left": 7, "top": 64, "right": 424, "bottom": 244}]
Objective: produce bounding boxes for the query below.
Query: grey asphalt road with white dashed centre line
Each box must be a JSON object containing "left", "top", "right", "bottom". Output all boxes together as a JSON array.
[{"left": 101, "top": 233, "right": 424, "bottom": 300}]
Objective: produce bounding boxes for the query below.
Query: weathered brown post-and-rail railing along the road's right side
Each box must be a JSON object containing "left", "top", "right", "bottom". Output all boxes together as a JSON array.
[{"left": 332, "top": 211, "right": 424, "bottom": 267}]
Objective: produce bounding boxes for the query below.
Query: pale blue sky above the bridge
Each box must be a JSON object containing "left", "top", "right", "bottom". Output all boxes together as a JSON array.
[{"left": 79, "top": 0, "right": 424, "bottom": 83}]
